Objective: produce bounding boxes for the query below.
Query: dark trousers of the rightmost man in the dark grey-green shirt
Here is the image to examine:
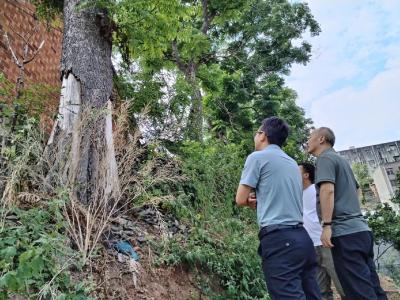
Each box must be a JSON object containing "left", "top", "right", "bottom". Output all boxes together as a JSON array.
[{"left": 332, "top": 231, "right": 387, "bottom": 300}]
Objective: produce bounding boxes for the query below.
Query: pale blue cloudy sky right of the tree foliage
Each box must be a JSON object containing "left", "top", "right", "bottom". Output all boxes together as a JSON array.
[{"left": 286, "top": 0, "right": 400, "bottom": 150}]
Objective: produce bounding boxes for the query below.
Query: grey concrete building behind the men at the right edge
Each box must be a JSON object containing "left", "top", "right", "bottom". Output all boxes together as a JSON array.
[{"left": 338, "top": 141, "right": 400, "bottom": 203}]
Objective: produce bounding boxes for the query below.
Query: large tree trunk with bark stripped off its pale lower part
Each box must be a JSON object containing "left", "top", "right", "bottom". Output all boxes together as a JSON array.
[{"left": 47, "top": 0, "right": 119, "bottom": 204}]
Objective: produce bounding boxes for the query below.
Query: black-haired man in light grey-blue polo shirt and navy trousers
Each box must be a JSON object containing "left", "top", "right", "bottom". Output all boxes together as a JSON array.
[{"left": 236, "top": 117, "right": 321, "bottom": 300}]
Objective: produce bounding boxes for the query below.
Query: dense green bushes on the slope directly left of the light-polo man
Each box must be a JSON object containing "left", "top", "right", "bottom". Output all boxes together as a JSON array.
[{"left": 158, "top": 141, "right": 267, "bottom": 299}]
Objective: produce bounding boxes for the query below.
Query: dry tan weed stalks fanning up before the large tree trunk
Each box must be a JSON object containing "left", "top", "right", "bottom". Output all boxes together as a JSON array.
[{"left": 47, "top": 105, "right": 185, "bottom": 261}]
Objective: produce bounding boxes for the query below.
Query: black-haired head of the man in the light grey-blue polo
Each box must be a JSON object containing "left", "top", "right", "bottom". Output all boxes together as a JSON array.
[{"left": 254, "top": 117, "right": 289, "bottom": 150}]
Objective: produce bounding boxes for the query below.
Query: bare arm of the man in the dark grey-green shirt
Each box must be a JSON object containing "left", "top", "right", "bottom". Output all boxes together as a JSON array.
[{"left": 319, "top": 182, "right": 335, "bottom": 248}]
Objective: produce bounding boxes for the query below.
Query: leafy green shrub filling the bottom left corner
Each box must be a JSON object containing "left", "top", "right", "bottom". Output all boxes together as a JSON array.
[{"left": 0, "top": 200, "right": 91, "bottom": 299}]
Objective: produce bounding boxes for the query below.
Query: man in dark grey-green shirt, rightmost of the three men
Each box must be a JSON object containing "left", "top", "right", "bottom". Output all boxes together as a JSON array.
[{"left": 308, "top": 127, "right": 387, "bottom": 300}]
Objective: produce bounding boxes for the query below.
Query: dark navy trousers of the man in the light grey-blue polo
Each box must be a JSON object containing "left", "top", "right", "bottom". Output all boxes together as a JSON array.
[{"left": 259, "top": 227, "right": 321, "bottom": 300}]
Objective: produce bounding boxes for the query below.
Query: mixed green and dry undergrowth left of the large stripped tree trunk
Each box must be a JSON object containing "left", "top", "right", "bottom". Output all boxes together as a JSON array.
[{"left": 0, "top": 89, "right": 90, "bottom": 299}]
